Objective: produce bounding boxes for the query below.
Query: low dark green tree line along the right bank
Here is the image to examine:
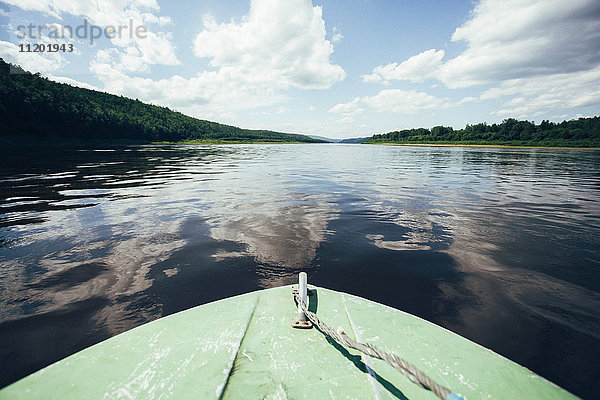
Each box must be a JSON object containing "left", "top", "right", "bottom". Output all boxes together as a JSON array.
[{"left": 365, "top": 117, "right": 600, "bottom": 147}]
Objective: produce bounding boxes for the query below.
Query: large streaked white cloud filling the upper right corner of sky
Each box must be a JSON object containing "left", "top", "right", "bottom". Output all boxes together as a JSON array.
[{"left": 363, "top": 0, "right": 600, "bottom": 118}]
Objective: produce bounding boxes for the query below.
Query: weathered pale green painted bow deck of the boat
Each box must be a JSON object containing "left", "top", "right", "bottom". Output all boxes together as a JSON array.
[{"left": 0, "top": 287, "right": 575, "bottom": 400}]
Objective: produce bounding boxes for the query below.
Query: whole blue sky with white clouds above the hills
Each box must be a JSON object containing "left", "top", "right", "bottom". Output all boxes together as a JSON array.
[{"left": 0, "top": 0, "right": 600, "bottom": 138}]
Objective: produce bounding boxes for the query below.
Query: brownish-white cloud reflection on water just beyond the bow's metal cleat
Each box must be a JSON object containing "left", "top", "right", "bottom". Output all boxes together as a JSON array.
[{"left": 209, "top": 192, "right": 335, "bottom": 287}]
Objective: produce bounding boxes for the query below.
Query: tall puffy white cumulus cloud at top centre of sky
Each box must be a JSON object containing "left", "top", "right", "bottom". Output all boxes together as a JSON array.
[{"left": 194, "top": 0, "right": 345, "bottom": 89}]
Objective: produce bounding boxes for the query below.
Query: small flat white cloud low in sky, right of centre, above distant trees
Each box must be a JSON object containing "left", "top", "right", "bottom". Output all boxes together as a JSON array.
[{"left": 329, "top": 89, "right": 451, "bottom": 116}]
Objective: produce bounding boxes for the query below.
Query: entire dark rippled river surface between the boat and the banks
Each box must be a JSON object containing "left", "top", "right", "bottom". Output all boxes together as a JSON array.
[{"left": 0, "top": 144, "right": 600, "bottom": 399}]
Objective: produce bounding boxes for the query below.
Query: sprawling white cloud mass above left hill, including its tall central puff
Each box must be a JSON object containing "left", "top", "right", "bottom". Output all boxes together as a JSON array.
[{"left": 83, "top": 0, "right": 345, "bottom": 120}]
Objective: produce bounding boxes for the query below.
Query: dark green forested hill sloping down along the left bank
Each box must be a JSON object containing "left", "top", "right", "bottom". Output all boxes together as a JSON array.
[{"left": 0, "top": 58, "right": 323, "bottom": 144}]
